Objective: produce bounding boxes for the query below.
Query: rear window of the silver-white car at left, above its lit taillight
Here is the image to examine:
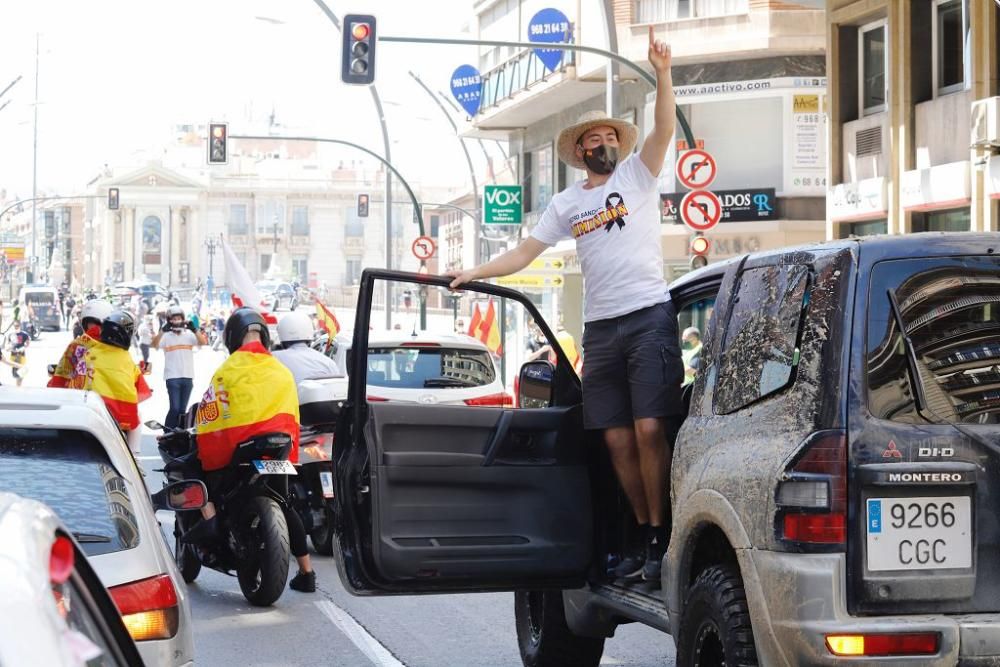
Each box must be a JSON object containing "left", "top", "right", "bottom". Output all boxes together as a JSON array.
[{"left": 0, "top": 428, "right": 139, "bottom": 556}]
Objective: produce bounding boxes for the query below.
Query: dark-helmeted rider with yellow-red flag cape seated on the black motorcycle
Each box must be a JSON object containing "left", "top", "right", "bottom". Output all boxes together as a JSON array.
[{"left": 182, "top": 308, "right": 316, "bottom": 593}]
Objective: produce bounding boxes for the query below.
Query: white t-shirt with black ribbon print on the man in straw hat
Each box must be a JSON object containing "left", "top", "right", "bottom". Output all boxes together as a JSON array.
[{"left": 531, "top": 154, "right": 670, "bottom": 322}]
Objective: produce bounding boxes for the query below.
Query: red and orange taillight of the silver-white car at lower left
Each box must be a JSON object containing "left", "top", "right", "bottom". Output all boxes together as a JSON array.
[{"left": 108, "top": 574, "right": 179, "bottom": 642}]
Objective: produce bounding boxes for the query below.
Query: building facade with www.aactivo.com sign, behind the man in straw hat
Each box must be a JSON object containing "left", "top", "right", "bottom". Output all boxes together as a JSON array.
[{"left": 468, "top": 0, "right": 827, "bottom": 334}]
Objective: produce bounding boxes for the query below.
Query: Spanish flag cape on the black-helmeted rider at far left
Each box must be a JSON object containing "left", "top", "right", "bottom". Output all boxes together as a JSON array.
[{"left": 66, "top": 334, "right": 153, "bottom": 431}]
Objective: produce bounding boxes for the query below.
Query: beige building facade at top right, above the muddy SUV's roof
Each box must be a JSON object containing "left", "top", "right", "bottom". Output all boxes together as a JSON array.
[{"left": 827, "top": 0, "right": 1000, "bottom": 238}]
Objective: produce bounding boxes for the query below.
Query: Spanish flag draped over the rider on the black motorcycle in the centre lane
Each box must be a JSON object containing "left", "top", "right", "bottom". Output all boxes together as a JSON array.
[{"left": 197, "top": 343, "right": 299, "bottom": 471}]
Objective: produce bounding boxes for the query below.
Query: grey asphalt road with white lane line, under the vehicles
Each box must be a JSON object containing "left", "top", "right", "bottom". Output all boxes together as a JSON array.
[{"left": 23, "top": 324, "right": 674, "bottom": 667}]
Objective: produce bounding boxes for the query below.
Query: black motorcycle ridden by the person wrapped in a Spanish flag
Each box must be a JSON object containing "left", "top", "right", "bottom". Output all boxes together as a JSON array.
[{"left": 146, "top": 406, "right": 296, "bottom": 607}]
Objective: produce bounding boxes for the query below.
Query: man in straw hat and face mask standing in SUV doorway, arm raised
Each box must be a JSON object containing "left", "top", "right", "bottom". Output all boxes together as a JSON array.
[{"left": 448, "top": 26, "right": 684, "bottom": 582}]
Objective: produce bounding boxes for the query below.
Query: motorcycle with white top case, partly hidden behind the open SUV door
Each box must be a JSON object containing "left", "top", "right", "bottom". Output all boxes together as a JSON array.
[{"left": 288, "top": 378, "right": 347, "bottom": 556}]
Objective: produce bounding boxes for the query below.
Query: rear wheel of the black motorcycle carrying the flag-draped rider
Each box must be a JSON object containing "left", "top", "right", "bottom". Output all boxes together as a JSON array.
[{"left": 236, "top": 496, "right": 289, "bottom": 607}]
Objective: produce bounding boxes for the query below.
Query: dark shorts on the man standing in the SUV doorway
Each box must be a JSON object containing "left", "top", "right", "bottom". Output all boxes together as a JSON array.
[{"left": 583, "top": 301, "right": 684, "bottom": 429}]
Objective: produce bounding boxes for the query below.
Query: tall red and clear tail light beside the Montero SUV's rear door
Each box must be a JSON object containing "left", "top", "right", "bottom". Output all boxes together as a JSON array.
[{"left": 775, "top": 430, "right": 847, "bottom": 549}]
